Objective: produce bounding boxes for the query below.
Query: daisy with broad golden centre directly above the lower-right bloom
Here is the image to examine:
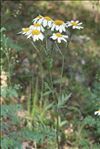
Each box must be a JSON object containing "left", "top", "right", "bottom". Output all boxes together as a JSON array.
[{"left": 51, "top": 20, "right": 66, "bottom": 33}]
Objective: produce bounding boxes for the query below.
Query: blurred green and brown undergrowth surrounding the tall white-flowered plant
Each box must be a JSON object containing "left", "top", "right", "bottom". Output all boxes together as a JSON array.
[{"left": 0, "top": 0, "right": 100, "bottom": 149}]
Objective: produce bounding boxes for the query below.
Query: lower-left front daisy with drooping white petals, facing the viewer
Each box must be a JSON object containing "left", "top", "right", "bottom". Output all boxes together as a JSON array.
[{"left": 27, "top": 30, "right": 44, "bottom": 42}]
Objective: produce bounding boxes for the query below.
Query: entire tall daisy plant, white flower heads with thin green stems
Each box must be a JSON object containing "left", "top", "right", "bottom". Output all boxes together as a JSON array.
[{"left": 20, "top": 15, "right": 83, "bottom": 149}]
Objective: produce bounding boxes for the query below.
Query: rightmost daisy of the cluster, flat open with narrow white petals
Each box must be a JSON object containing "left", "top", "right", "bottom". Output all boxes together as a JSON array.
[{"left": 66, "top": 20, "right": 83, "bottom": 29}]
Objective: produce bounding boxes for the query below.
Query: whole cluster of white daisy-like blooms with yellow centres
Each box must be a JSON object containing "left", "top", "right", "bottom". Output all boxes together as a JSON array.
[{"left": 20, "top": 15, "right": 83, "bottom": 43}]
